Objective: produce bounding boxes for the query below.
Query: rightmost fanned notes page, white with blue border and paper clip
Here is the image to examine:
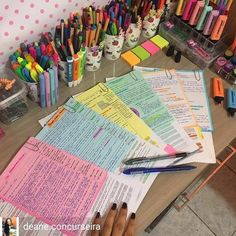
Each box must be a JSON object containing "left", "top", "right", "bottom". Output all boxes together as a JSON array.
[{"left": 176, "top": 70, "right": 213, "bottom": 131}]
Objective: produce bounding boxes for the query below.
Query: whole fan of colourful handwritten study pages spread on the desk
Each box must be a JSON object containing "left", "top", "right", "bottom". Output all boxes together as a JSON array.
[{"left": 0, "top": 66, "right": 216, "bottom": 235}]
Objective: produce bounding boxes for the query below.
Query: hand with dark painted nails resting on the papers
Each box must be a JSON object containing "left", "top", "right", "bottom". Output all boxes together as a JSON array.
[{"left": 91, "top": 202, "right": 135, "bottom": 236}]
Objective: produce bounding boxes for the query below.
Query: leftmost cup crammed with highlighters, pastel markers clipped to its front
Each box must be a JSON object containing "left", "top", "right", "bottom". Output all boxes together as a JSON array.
[{"left": 9, "top": 33, "right": 59, "bottom": 108}]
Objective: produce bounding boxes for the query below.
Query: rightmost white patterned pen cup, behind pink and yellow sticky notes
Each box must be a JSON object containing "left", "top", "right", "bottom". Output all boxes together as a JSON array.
[{"left": 142, "top": 15, "right": 160, "bottom": 38}]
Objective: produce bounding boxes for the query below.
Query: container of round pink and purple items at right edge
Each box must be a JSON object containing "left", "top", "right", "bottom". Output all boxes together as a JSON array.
[{"left": 214, "top": 50, "right": 236, "bottom": 85}]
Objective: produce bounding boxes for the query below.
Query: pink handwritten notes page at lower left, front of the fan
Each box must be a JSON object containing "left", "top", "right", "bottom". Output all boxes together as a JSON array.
[{"left": 0, "top": 138, "right": 107, "bottom": 235}]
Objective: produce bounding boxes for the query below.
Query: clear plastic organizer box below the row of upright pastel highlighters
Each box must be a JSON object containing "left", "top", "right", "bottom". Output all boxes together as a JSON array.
[{"left": 159, "top": 15, "right": 227, "bottom": 69}]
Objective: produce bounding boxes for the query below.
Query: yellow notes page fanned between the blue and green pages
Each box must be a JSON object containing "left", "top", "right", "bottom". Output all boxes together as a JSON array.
[{"left": 74, "top": 83, "right": 159, "bottom": 146}]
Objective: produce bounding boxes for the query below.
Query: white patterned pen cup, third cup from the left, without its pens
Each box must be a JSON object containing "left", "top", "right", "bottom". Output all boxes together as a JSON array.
[{"left": 85, "top": 42, "right": 104, "bottom": 71}]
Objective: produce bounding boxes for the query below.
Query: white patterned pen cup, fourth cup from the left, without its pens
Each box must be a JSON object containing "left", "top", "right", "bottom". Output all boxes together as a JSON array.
[{"left": 104, "top": 34, "right": 124, "bottom": 60}]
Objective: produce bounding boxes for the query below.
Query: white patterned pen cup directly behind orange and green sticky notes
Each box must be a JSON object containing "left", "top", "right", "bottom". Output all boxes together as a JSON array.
[{"left": 125, "top": 19, "right": 142, "bottom": 48}]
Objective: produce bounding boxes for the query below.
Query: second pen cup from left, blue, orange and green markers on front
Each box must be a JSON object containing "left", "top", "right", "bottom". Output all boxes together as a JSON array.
[{"left": 54, "top": 13, "right": 86, "bottom": 87}]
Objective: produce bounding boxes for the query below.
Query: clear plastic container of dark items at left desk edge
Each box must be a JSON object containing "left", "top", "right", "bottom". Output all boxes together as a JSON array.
[{"left": 0, "top": 69, "right": 28, "bottom": 124}]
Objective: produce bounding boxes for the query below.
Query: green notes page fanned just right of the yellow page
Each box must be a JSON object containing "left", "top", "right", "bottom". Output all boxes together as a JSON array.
[{"left": 106, "top": 71, "right": 196, "bottom": 151}]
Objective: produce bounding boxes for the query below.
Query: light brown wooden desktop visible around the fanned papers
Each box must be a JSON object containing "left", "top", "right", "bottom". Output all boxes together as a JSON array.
[{"left": 0, "top": 49, "right": 236, "bottom": 235}]
